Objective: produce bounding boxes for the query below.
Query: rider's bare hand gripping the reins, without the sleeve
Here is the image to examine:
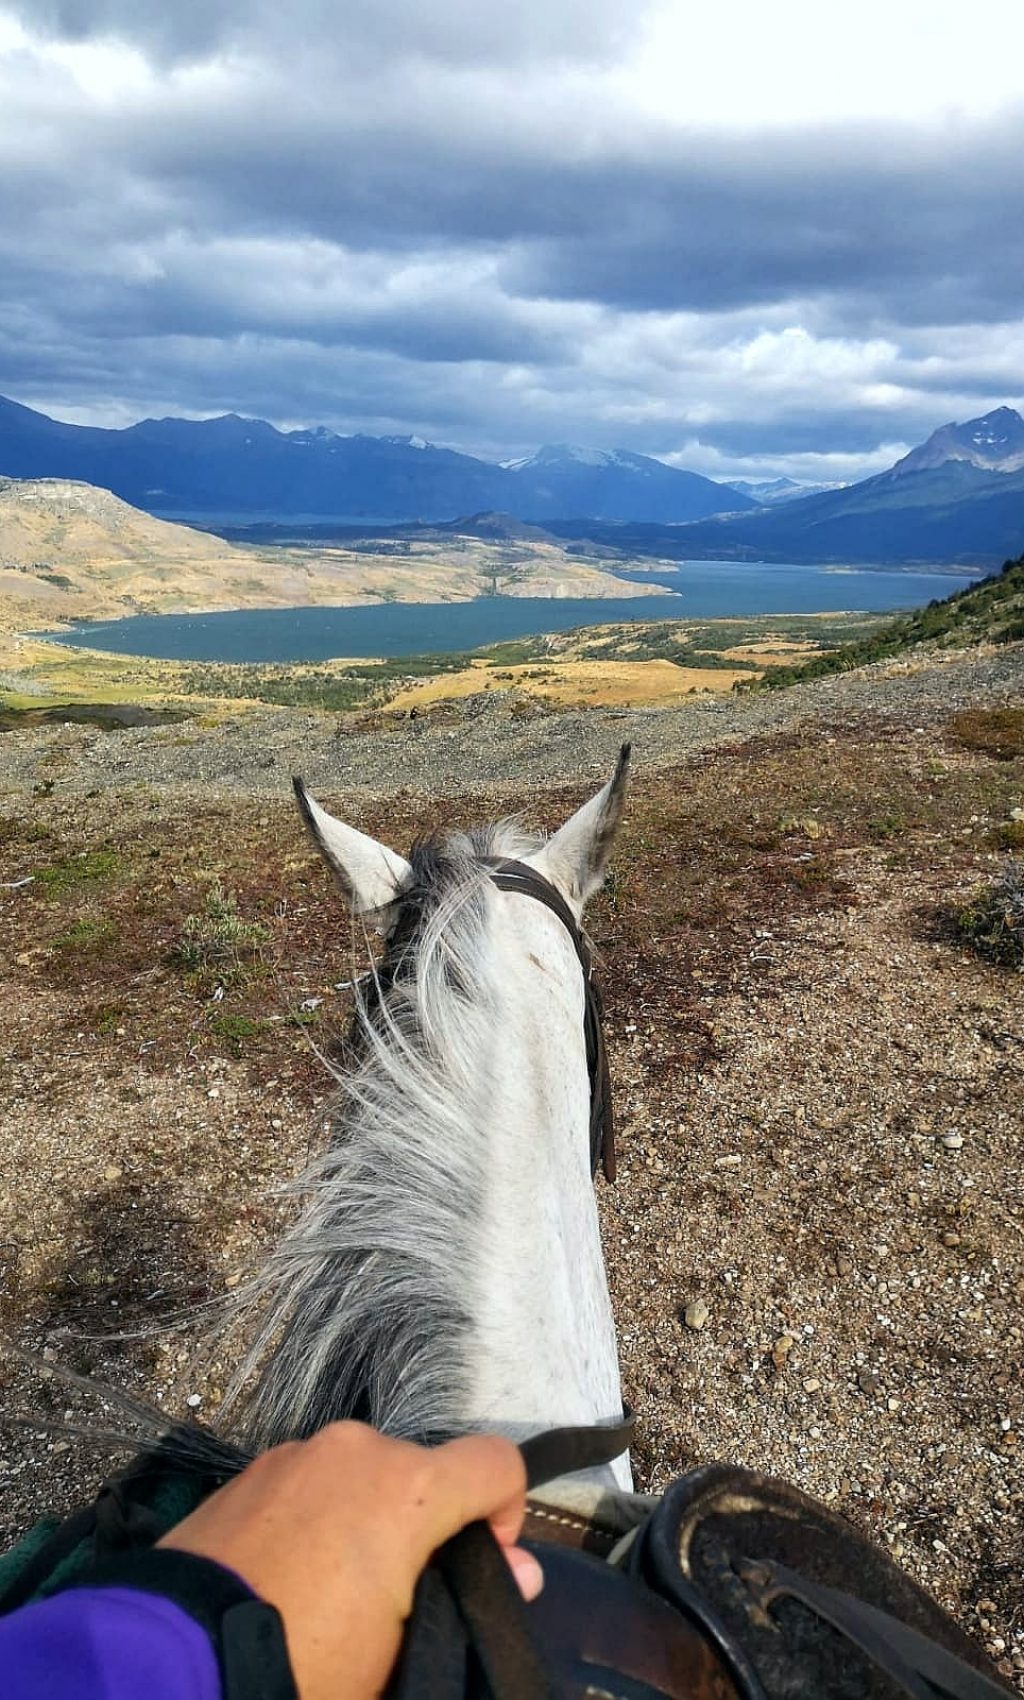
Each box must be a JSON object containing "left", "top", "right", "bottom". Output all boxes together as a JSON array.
[{"left": 158, "top": 1423, "right": 543, "bottom": 1700}]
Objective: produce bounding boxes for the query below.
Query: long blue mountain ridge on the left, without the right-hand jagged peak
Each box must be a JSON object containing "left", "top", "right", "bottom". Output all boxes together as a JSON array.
[{"left": 0, "top": 396, "right": 754, "bottom": 524}]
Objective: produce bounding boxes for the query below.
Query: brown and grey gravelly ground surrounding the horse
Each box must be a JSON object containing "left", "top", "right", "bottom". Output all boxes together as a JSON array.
[{"left": 0, "top": 648, "right": 1024, "bottom": 1692}]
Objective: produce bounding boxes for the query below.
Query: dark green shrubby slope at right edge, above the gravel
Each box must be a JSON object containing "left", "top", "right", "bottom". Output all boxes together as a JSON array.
[{"left": 748, "top": 554, "right": 1024, "bottom": 689}]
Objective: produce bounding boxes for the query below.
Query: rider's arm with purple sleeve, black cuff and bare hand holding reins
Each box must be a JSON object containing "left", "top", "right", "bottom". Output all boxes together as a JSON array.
[{"left": 0, "top": 1423, "right": 541, "bottom": 1700}]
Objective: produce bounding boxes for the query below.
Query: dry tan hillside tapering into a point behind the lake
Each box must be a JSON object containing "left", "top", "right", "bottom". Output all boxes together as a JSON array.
[{"left": 0, "top": 479, "right": 657, "bottom": 629}]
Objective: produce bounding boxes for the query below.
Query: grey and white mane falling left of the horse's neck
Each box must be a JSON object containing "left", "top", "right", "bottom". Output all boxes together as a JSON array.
[{"left": 225, "top": 821, "right": 539, "bottom": 1448}]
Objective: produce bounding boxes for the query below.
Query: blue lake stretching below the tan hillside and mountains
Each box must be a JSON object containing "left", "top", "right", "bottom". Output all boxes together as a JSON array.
[{"left": 44, "top": 561, "right": 975, "bottom": 661}]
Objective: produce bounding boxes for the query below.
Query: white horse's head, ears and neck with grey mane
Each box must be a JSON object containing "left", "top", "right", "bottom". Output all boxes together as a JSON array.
[{"left": 227, "top": 746, "right": 631, "bottom": 1505}]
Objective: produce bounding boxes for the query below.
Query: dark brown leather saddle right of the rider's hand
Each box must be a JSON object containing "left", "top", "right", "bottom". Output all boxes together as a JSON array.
[{"left": 388, "top": 1443, "right": 1010, "bottom": 1700}]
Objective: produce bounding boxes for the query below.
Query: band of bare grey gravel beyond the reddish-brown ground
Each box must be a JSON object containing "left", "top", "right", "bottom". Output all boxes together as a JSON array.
[{"left": 0, "top": 646, "right": 1024, "bottom": 797}]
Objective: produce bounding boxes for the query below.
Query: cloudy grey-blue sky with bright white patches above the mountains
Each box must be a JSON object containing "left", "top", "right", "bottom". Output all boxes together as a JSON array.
[{"left": 0, "top": 0, "right": 1024, "bottom": 479}]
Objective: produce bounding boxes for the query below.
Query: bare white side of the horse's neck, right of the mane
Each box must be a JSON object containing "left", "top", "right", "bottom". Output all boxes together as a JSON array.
[{"left": 466, "top": 894, "right": 629, "bottom": 1486}]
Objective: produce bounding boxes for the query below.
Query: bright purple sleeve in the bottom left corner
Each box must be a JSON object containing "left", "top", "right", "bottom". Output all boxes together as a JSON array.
[{"left": 0, "top": 1588, "right": 221, "bottom": 1700}]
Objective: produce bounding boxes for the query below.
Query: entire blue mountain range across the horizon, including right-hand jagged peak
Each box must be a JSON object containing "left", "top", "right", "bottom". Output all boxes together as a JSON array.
[{"left": 0, "top": 398, "right": 1024, "bottom": 568}]
